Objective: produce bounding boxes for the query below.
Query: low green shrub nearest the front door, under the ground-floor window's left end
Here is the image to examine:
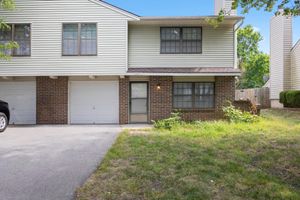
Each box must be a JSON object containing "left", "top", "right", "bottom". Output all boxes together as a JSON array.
[{"left": 152, "top": 112, "right": 182, "bottom": 130}]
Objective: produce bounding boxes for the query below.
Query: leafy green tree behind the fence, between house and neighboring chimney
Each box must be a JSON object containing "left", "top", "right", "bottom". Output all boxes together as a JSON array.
[{"left": 237, "top": 25, "right": 270, "bottom": 88}]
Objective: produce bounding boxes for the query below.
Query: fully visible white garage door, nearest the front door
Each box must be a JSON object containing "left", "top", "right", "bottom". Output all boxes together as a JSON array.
[{"left": 70, "top": 81, "right": 119, "bottom": 124}]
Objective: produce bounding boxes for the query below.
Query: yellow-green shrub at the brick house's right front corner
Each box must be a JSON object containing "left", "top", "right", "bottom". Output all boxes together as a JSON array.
[{"left": 223, "top": 103, "right": 258, "bottom": 123}]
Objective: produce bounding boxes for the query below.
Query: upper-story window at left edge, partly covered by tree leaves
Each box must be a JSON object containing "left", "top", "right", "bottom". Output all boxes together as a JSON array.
[{"left": 0, "top": 24, "right": 31, "bottom": 56}]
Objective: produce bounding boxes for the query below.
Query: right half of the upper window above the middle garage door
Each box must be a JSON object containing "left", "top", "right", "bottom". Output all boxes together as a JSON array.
[{"left": 80, "top": 24, "right": 97, "bottom": 55}]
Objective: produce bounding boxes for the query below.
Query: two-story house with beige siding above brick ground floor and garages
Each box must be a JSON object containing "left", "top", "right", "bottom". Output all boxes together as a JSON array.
[{"left": 0, "top": 0, "right": 243, "bottom": 124}]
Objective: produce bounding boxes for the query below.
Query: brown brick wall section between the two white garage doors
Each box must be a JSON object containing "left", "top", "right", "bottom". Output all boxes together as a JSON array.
[{"left": 37, "top": 77, "right": 68, "bottom": 124}]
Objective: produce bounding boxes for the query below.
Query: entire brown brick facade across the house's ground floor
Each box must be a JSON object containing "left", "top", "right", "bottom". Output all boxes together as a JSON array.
[{"left": 37, "top": 76, "right": 235, "bottom": 124}]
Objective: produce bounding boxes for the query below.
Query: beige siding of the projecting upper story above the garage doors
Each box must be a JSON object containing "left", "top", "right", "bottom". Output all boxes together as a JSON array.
[{"left": 0, "top": 0, "right": 130, "bottom": 76}]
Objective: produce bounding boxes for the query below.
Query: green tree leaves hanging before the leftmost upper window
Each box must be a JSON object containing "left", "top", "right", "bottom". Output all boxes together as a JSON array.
[{"left": 0, "top": 0, "right": 18, "bottom": 60}]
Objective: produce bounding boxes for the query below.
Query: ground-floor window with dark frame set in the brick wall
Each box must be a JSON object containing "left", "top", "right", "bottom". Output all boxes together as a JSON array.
[{"left": 173, "top": 82, "right": 215, "bottom": 109}]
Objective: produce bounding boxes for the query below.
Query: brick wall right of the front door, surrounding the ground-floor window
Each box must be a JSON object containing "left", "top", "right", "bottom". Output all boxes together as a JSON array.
[{"left": 150, "top": 77, "right": 235, "bottom": 121}]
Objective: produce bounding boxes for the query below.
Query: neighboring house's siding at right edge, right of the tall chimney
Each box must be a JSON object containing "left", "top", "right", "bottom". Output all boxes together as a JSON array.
[{"left": 291, "top": 40, "right": 300, "bottom": 90}]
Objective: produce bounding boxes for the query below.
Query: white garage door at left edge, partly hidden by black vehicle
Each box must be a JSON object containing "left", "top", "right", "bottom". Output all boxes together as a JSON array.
[{"left": 0, "top": 81, "right": 36, "bottom": 124}]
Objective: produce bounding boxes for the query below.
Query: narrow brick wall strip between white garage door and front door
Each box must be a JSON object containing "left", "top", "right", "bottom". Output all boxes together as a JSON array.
[{"left": 119, "top": 77, "right": 129, "bottom": 124}]
